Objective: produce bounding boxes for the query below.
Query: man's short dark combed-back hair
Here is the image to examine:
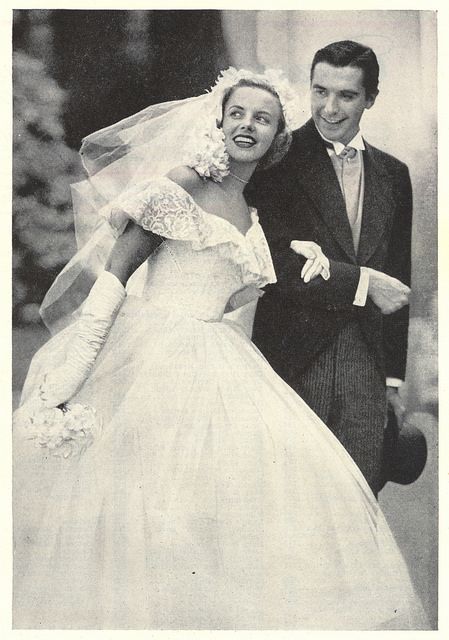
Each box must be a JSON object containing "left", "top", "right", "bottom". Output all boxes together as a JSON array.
[{"left": 310, "top": 40, "right": 379, "bottom": 96}]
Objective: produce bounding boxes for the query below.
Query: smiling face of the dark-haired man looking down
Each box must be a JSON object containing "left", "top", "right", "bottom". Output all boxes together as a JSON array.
[{"left": 311, "top": 62, "right": 375, "bottom": 144}]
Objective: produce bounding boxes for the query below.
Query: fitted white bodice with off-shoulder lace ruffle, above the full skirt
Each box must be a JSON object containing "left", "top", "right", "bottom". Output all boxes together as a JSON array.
[{"left": 103, "top": 178, "right": 276, "bottom": 321}]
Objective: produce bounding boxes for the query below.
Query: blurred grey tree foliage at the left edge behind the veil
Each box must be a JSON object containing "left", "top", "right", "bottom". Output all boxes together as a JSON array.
[{"left": 13, "top": 51, "right": 81, "bottom": 322}]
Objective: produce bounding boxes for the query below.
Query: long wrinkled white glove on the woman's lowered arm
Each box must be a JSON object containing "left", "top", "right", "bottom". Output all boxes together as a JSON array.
[{"left": 39, "top": 271, "right": 126, "bottom": 408}]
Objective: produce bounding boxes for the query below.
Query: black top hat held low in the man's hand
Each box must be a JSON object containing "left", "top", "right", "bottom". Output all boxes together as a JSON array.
[{"left": 379, "top": 408, "right": 427, "bottom": 490}]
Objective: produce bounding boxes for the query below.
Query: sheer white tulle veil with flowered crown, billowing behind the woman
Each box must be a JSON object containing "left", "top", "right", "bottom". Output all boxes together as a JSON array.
[{"left": 41, "top": 68, "right": 299, "bottom": 334}]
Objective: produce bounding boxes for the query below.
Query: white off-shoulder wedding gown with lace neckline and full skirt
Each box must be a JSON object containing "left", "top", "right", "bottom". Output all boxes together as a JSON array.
[{"left": 14, "top": 178, "right": 426, "bottom": 629}]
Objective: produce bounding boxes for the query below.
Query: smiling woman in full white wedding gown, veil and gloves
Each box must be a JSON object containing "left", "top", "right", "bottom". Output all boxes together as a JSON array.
[{"left": 14, "top": 69, "right": 426, "bottom": 629}]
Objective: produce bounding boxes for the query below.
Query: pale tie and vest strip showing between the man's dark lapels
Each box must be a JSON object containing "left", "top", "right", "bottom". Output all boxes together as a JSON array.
[{"left": 338, "top": 147, "right": 361, "bottom": 252}]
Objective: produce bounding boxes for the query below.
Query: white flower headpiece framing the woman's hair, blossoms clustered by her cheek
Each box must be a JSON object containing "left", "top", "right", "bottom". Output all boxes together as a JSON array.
[{"left": 187, "top": 67, "right": 300, "bottom": 182}]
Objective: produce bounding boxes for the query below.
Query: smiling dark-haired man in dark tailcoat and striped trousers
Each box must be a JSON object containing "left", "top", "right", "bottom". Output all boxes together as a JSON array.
[{"left": 248, "top": 41, "right": 412, "bottom": 494}]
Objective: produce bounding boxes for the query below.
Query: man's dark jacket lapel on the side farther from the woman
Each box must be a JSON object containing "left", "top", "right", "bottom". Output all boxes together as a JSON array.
[{"left": 357, "top": 144, "right": 394, "bottom": 265}]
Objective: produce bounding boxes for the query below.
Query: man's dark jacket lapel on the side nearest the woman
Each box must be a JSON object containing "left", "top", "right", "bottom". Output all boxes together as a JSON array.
[{"left": 295, "top": 121, "right": 356, "bottom": 263}]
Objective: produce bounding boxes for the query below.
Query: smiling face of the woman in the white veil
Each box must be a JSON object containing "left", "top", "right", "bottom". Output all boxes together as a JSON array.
[{"left": 222, "top": 87, "right": 282, "bottom": 162}]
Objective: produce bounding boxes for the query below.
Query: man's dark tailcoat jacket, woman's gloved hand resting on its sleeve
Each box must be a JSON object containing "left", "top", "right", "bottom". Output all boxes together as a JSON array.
[{"left": 245, "top": 120, "right": 412, "bottom": 381}]
